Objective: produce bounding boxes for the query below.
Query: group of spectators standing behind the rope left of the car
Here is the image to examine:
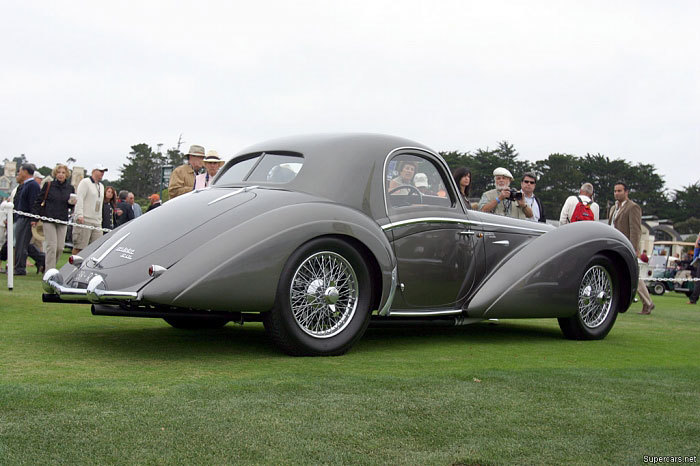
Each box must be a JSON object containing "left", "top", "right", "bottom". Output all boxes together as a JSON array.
[{"left": 0, "top": 145, "right": 225, "bottom": 275}]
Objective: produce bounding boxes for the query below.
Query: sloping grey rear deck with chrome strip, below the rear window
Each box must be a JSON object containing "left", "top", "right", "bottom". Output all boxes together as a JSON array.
[{"left": 61, "top": 187, "right": 315, "bottom": 290}]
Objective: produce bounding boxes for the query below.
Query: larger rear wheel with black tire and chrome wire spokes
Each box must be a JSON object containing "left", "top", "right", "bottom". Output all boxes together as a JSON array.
[{"left": 263, "top": 238, "right": 371, "bottom": 356}]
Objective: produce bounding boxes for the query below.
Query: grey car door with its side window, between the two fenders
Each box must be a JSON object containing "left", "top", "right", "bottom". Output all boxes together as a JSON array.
[{"left": 385, "top": 150, "right": 482, "bottom": 312}]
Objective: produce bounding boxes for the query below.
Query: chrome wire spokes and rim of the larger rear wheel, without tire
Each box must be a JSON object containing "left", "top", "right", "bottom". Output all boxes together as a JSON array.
[{"left": 289, "top": 251, "right": 359, "bottom": 338}]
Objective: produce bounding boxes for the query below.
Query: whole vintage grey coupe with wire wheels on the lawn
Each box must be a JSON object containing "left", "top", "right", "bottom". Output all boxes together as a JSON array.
[{"left": 43, "top": 134, "right": 638, "bottom": 355}]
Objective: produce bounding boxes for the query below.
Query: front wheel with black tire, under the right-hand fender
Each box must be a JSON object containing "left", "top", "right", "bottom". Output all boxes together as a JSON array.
[{"left": 558, "top": 254, "right": 620, "bottom": 340}]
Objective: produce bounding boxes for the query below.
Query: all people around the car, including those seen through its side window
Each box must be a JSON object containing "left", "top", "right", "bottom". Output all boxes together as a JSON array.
[{"left": 0, "top": 149, "right": 700, "bottom": 315}]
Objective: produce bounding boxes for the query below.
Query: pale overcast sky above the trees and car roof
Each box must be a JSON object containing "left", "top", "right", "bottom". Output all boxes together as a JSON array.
[{"left": 0, "top": 0, "right": 700, "bottom": 190}]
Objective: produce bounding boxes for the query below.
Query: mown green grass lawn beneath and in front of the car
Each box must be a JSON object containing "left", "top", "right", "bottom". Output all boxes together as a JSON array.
[{"left": 0, "top": 260, "right": 700, "bottom": 465}]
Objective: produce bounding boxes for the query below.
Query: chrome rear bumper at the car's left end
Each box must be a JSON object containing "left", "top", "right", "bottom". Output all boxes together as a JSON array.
[{"left": 42, "top": 269, "right": 138, "bottom": 304}]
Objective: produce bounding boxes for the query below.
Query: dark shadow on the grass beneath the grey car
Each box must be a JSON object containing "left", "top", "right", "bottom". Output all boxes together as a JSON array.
[{"left": 40, "top": 321, "right": 562, "bottom": 360}]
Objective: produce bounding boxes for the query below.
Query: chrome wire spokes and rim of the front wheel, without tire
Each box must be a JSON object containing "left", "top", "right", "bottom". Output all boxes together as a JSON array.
[{"left": 578, "top": 265, "right": 613, "bottom": 328}]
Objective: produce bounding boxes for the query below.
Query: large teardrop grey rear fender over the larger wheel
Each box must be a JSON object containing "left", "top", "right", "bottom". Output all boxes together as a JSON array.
[{"left": 142, "top": 202, "right": 396, "bottom": 312}]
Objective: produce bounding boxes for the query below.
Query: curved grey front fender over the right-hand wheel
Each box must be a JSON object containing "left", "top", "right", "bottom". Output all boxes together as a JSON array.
[{"left": 467, "top": 222, "right": 638, "bottom": 318}]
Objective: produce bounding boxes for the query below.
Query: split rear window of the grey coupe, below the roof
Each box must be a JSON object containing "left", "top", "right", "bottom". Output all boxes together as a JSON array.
[{"left": 214, "top": 153, "right": 304, "bottom": 185}]
